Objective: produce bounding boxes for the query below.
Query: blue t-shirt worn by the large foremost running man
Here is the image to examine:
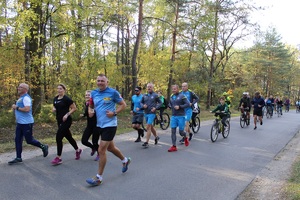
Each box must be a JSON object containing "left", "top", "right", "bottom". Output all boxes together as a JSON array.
[{"left": 91, "top": 87, "right": 123, "bottom": 128}]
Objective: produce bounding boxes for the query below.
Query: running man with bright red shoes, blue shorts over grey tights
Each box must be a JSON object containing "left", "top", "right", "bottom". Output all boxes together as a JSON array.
[{"left": 168, "top": 85, "right": 190, "bottom": 152}]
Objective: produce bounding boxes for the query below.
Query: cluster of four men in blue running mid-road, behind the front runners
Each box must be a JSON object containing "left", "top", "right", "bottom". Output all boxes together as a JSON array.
[{"left": 130, "top": 83, "right": 199, "bottom": 152}]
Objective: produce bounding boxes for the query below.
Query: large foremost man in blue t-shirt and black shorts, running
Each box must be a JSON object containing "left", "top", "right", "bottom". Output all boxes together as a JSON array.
[{"left": 86, "top": 74, "right": 131, "bottom": 186}]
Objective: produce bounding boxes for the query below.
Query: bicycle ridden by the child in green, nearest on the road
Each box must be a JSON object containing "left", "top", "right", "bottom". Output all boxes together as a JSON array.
[{"left": 210, "top": 112, "right": 230, "bottom": 142}]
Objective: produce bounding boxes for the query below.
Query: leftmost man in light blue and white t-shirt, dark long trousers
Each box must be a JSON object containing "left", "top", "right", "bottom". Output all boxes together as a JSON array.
[{"left": 8, "top": 83, "right": 48, "bottom": 165}]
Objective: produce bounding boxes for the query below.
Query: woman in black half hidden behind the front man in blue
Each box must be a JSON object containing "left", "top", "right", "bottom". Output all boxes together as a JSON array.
[{"left": 81, "top": 90, "right": 99, "bottom": 161}]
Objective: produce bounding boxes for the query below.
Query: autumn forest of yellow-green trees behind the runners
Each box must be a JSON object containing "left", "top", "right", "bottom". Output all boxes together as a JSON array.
[{"left": 0, "top": 0, "right": 300, "bottom": 124}]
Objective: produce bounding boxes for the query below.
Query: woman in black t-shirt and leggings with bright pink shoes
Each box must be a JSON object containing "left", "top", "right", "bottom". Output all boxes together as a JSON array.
[{"left": 51, "top": 84, "right": 82, "bottom": 165}]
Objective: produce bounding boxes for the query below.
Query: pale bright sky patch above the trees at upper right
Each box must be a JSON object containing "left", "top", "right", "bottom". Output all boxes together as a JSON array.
[{"left": 240, "top": 0, "right": 300, "bottom": 47}]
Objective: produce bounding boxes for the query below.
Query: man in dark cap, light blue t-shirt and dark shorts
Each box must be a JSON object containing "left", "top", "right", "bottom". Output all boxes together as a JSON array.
[{"left": 130, "top": 87, "right": 144, "bottom": 142}]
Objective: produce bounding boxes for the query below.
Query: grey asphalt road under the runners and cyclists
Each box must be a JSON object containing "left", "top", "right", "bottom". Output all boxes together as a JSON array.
[{"left": 0, "top": 111, "right": 300, "bottom": 200}]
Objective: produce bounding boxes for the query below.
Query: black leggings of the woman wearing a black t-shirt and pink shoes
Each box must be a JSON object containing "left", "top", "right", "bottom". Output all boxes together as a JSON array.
[{"left": 56, "top": 118, "right": 78, "bottom": 156}]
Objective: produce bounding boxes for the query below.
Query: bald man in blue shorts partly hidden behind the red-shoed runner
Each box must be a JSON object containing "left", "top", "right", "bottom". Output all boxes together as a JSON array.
[{"left": 179, "top": 82, "right": 199, "bottom": 143}]
